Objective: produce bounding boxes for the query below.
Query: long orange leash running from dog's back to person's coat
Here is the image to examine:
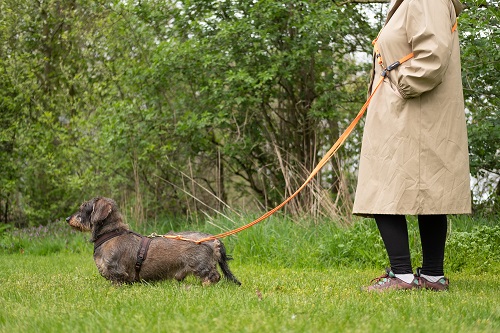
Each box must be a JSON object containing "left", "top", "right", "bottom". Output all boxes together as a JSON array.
[{"left": 160, "top": 20, "right": 458, "bottom": 244}]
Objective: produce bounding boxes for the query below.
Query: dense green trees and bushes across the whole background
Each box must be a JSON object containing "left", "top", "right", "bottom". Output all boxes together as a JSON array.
[{"left": 0, "top": 0, "right": 500, "bottom": 224}]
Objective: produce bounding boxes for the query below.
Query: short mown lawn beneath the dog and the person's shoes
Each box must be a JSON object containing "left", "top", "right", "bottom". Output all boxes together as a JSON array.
[{"left": 0, "top": 252, "right": 500, "bottom": 333}]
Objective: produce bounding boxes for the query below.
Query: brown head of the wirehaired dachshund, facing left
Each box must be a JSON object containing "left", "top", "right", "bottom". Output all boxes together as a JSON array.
[{"left": 66, "top": 197, "right": 116, "bottom": 231}]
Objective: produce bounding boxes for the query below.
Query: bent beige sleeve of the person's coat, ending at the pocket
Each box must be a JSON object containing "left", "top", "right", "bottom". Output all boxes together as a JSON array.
[{"left": 398, "top": 0, "right": 455, "bottom": 98}]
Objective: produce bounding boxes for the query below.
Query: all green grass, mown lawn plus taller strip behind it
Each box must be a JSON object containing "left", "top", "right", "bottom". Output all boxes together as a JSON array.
[{"left": 0, "top": 218, "right": 500, "bottom": 333}]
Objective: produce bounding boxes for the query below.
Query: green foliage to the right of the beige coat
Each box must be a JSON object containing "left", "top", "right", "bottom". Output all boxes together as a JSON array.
[{"left": 459, "top": 0, "right": 500, "bottom": 216}]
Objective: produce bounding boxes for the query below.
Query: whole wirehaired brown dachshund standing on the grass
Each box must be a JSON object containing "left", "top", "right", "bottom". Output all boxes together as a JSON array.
[{"left": 66, "top": 197, "right": 241, "bottom": 285}]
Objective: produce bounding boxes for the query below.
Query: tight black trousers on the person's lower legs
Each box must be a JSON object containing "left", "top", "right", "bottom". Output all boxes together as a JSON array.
[{"left": 374, "top": 215, "right": 447, "bottom": 276}]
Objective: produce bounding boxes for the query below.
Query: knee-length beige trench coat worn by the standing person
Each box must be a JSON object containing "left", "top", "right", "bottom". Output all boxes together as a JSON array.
[{"left": 353, "top": 0, "right": 471, "bottom": 216}]
